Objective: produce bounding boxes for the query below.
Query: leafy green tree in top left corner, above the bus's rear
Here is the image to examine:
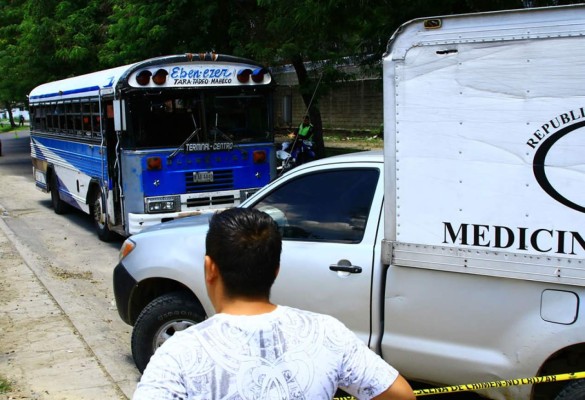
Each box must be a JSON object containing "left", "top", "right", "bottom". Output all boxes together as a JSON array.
[{"left": 0, "top": 0, "right": 110, "bottom": 123}]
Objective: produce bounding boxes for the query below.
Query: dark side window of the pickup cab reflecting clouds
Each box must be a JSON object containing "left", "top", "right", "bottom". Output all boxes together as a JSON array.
[{"left": 254, "top": 168, "right": 380, "bottom": 243}]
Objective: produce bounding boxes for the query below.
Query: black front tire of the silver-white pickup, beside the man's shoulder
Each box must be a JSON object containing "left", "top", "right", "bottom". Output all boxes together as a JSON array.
[{"left": 132, "top": 292, "right": 205, "bottom": 373}]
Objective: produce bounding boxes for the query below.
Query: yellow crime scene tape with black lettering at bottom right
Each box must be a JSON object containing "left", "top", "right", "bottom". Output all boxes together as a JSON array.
[{"left": 333, "top": 371, "right": 585, "bottom": 400}]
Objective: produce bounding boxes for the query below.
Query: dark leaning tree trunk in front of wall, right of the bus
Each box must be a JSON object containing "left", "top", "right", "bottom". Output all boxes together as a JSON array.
[{"left": 292, "top": 54, "right": 325, "bottom": 158}]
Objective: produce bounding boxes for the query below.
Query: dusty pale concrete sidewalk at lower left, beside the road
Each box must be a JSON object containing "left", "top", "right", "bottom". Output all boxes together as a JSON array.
[{"left": 0, "top": 214, "right": 127, "bottom": 400}]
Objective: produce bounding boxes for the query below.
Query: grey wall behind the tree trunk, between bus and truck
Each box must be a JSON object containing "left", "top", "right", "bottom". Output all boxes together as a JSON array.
[{"left": 274, "top": 77, "right": 383, "bottom": 133}]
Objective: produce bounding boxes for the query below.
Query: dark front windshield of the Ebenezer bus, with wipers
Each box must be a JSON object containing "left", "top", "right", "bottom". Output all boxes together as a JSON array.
[{"left": 125, "top": 90, "right": 273, "bottom": 148}]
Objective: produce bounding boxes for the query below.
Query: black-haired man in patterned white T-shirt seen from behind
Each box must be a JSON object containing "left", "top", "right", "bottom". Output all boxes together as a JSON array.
[{"left": 133, "top": 208, "right": 414, "bottom": 400}]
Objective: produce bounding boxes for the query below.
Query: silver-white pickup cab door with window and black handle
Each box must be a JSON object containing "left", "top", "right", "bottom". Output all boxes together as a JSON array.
[{"left": 253, "top": 163, "right": 383, "bottom": 343}]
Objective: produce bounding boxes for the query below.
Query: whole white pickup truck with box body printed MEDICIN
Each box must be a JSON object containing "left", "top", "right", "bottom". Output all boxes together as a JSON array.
[{"left": 114, "top": 6, "right": 585, "bottom": 399}]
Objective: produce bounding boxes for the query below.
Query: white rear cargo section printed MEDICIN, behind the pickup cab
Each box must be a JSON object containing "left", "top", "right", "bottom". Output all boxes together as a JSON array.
[{"left": 381, "top": 6, "right": 585, "bottom": 398}]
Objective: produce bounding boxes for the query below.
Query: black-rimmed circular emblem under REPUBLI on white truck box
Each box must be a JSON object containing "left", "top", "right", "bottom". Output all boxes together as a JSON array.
[{"left": 532, "top": 121, "right": 585, "bottom": 212}]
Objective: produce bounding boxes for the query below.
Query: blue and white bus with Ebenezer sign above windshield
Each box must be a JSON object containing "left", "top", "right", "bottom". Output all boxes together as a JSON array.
[{"left": 29, "top": 53, "right": 276, "bottom": 240}]
